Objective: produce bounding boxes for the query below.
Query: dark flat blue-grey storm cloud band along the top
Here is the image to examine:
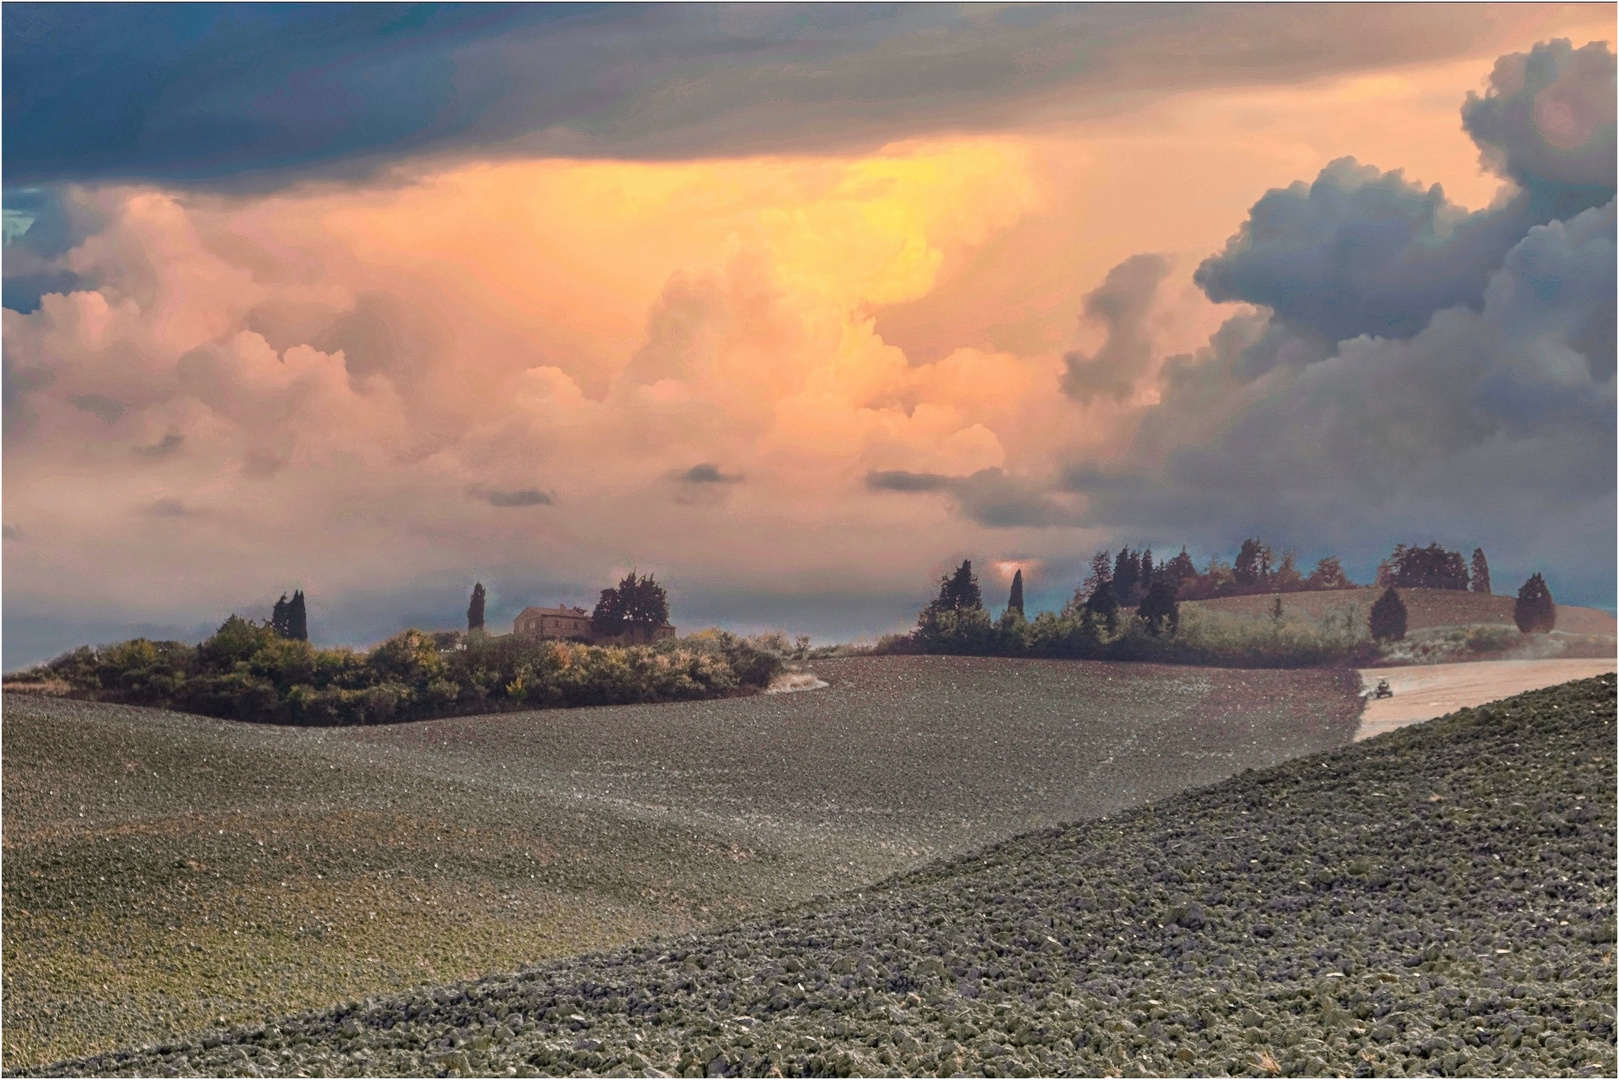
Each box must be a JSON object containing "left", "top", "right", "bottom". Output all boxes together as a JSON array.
[{"left": 3, "top": 3, "right": 1580, "bottom": 187}]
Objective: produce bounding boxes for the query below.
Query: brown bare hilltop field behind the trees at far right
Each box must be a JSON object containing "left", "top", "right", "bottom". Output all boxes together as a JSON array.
[{"left": 1185, "top": 588, "right": 1619, "bottom": 635}]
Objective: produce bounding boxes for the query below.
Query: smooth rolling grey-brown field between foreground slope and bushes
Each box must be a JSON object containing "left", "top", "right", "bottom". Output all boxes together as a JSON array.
[{"left": 3, "top": 656, "right": 1360, "bottom": 1069}]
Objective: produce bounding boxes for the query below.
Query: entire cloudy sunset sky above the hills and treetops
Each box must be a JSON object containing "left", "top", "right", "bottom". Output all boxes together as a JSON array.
[{"left": 0, "top": 3, "right": 1616, "bottom": 670}]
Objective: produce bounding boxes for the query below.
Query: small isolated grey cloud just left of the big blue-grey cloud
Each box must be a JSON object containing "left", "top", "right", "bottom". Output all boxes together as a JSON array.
[{"left": 1062, "top": 254, "right": 1171, "bottom": 402}]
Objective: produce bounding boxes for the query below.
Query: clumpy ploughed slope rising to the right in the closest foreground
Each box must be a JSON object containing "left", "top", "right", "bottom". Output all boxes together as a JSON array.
[{"left": 31, "top": 675, "right": 1616, "bottom": 1075}]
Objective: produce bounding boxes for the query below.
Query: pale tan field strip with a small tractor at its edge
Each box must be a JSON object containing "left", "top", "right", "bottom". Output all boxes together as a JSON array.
[{"left": 1355, "top": 657, "right": 1616, "bottom": 742}]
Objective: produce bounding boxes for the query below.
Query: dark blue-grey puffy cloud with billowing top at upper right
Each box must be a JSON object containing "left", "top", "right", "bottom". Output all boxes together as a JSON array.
[{"left": 1195, "top": 40, "right": 1616, "bottom": 342}]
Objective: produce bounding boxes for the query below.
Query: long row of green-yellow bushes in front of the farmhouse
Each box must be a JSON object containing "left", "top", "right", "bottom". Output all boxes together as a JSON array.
[{"left": 26, "top": 615, "right": 785, "bottom": 725}]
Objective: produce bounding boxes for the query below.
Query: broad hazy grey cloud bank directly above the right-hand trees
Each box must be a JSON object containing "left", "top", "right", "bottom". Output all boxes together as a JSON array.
[{"left": 1067, "top": 202, "right": 1616, "bottom": 588}]
